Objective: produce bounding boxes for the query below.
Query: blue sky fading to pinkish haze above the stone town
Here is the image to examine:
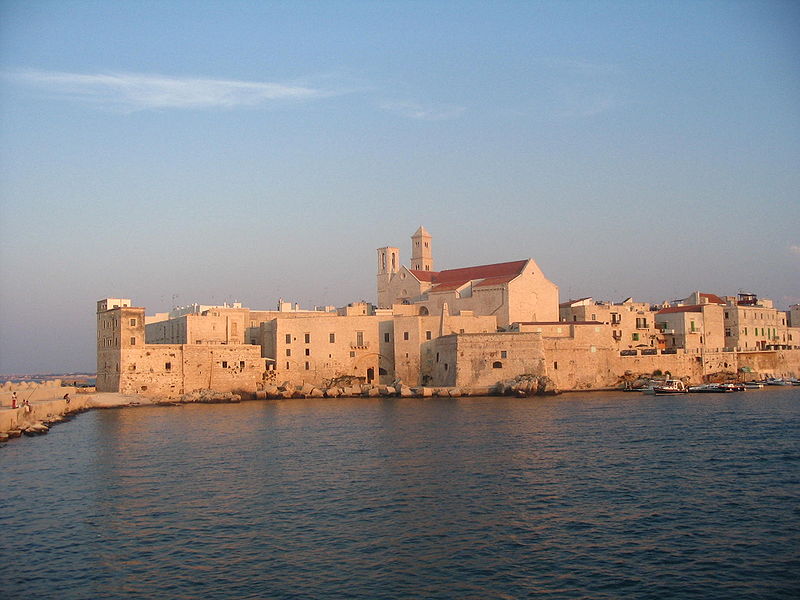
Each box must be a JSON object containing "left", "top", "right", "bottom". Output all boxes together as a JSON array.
[{"left": 0, "top": 0, "right": 800, "bottom": 373}]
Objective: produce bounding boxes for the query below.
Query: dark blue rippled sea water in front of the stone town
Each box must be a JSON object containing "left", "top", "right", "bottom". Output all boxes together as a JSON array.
[{"left": 0, "top": 388, "right": 800, "bottom": 600}]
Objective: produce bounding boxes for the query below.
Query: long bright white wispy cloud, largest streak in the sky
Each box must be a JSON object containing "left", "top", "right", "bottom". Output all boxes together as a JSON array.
[{"left": 11, "top": 70, "right": 334, "bottom": 111}]
